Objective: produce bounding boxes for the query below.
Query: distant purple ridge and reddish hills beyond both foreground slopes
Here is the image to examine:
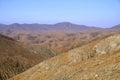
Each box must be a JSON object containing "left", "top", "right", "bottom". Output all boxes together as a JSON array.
[{"left": 0, "top": 22, "right": 119, "bottom": 53}]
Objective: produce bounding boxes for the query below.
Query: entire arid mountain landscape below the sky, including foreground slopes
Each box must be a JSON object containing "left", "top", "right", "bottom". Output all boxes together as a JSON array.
[{"left": 0, "top": 22, "right": 120, "bottom": 80}]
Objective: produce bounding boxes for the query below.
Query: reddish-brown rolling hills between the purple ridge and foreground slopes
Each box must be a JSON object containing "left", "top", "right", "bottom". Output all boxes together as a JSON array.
[{"left": 10, "top": 31, "right": 114, "bottom": 53}]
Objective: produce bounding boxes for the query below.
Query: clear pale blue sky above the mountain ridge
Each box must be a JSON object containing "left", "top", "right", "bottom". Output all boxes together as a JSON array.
[{"left": 0, "top": 0, "right": 120, "bottom": 27}]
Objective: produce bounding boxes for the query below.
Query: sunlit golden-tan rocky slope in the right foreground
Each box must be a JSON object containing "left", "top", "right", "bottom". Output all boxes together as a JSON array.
[{"left": 9, "top": 33, "right": 120, "bottom": 80}]
